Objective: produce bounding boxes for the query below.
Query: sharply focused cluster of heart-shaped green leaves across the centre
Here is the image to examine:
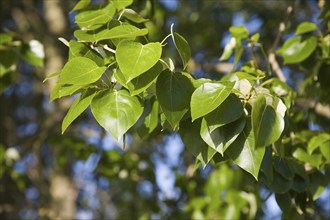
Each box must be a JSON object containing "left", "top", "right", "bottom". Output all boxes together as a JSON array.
[{"left": 47, "top": 1, "right": 286, "bottom": 179}]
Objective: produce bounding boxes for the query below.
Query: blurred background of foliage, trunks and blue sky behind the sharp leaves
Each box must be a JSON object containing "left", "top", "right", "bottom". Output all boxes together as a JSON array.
[{"left": 0, "top": 0, "right": 330, "bottom": 219}]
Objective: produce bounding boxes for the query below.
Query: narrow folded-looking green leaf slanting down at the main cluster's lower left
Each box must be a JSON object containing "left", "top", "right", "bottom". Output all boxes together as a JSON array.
[{"left": 62, "top": 90, "right": 96, "bottom": 134}]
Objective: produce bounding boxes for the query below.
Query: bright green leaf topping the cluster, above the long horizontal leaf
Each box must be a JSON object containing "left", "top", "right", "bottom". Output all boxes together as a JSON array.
[{"left": 76, "top": 3, "right": 116, "bottom": 30}]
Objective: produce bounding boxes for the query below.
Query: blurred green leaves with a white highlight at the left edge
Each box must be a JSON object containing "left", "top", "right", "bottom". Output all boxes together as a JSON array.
[{"left": 0, "top": 32, "right": 44, "bottom": 94}]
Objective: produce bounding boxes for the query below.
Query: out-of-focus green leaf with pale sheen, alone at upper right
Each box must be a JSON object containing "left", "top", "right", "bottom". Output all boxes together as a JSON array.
[{"left": 276, "top": 36, "right": 317, "bottom": 64}]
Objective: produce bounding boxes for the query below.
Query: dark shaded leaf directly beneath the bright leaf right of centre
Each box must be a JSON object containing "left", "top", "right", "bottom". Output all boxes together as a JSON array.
[{"left": 204, "top": 94, "right": 243, "bottom": 131}]
